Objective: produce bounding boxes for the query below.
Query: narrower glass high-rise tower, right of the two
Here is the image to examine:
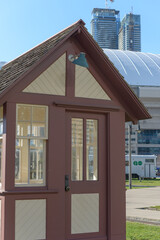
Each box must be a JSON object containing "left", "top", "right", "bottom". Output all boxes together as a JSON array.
[{"left": 119, "top": 13, "right": 141, "bottom": 52}]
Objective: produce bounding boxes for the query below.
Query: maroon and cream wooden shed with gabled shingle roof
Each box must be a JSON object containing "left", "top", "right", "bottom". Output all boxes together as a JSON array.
[{"left": 0, "top": 20, "right": 150, "bottom": 240}]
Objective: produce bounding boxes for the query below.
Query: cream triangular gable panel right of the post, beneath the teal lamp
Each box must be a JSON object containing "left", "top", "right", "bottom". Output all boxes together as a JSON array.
[{"left": 75, "top": 65, "right": 110, "bottom": 100}]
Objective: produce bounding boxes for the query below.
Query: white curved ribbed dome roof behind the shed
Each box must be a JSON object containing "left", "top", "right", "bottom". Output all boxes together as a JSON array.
[{"left": 103, "top": 49, "right": 160, "bottom": 86}]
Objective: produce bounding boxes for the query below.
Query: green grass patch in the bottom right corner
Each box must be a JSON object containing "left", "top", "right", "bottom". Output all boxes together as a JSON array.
[{"left": 126, "top": 222, "right": 160, "bottom": 240}]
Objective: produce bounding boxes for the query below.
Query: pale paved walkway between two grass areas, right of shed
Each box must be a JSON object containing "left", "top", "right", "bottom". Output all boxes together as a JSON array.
[{"left": 126, "top": 187, "right": 160, "bottom": 225}]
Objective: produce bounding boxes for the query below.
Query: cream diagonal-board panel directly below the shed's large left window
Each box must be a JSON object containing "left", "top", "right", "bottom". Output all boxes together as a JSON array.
[{"left": 15, "top": 199, "right": 46, "bottom": 240}]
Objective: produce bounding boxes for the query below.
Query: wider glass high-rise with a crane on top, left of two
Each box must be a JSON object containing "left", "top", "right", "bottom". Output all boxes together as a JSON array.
[{"left": 91, "top": 8, "right": 120, "bottom": 49}]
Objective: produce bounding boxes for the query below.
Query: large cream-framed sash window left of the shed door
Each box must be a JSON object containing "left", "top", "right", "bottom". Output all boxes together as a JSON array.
[{"left": 15, "top": 104, "right": 48, "bottom": 186}]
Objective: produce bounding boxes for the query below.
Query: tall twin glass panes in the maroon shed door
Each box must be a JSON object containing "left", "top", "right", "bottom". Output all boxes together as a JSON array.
[{"left": 71, "top": 118, "right": 98, "bottom": 181}]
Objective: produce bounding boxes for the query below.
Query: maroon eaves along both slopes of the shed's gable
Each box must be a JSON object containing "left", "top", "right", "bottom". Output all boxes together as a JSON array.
[{"left": 0, "top": 20, "right": 151, "bottom": 122}]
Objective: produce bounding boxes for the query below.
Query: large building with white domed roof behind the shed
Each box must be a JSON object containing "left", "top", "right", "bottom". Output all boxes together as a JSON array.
[{"left": 105, "top": 49, "right": 160, "bottom": 165}]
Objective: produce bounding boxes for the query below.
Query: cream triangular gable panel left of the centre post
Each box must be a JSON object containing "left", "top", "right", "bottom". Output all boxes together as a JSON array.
[{"left": 23, "top": 54, "right": 66, "bottom": 96}]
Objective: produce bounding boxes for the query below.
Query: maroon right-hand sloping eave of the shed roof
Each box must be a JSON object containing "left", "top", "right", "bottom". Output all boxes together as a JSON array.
[{"left": 74, "top": 26, "right": 151, "bottom": 123}]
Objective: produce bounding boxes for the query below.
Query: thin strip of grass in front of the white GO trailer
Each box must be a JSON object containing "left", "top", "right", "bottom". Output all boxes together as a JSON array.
[{"left": 126, "top": 178, "right": 160, "bottom": 187}]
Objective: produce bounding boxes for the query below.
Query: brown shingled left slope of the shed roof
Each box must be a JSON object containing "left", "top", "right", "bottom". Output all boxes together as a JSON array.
[{"left": 0, "top": 20, "right": 84, "bottom": 94}]
